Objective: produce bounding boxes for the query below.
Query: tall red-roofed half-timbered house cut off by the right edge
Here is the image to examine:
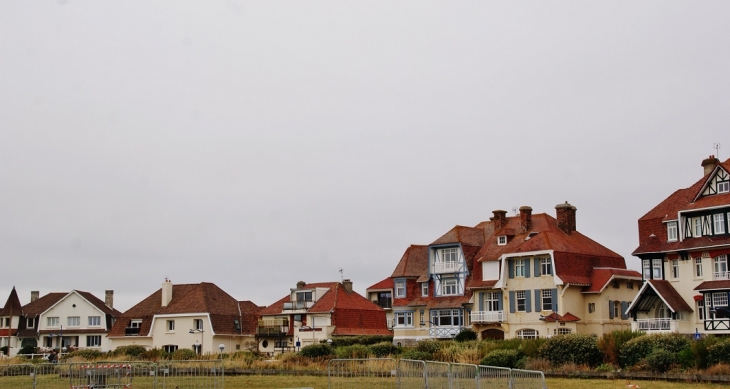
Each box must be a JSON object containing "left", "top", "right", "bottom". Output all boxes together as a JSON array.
[{"left": 628, "top": 156, "right": 730, "bottom": 334}]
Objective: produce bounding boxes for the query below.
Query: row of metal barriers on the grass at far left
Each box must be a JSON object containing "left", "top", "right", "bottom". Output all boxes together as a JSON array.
[{"left": 0, "top": 360, "right": 224, "bottom": 389}]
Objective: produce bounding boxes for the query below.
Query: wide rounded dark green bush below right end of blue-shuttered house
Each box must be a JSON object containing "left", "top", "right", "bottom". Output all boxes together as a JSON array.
[{"left": 539, "top": 334, "right": 603, "bottom": 367}]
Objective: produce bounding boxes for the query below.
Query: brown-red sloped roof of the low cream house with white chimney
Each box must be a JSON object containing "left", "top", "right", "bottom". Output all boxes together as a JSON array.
[{"left": 109, "top": 282, "right": 241, "bottom": 337}]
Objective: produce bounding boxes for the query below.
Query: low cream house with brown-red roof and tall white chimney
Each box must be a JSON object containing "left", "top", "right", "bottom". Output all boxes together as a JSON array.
[{"left": 109, "top": 279, "right": 261, "bottom": 354}]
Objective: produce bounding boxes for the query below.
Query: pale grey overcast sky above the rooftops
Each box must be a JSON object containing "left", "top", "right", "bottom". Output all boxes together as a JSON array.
[{"left": 0, "top": 0, "right": 730, "bottom": 311}]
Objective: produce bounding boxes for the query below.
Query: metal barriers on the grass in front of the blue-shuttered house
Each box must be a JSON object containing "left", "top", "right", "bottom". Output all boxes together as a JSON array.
[{"left": 327, "top": 358, "right": 547, "bottom": 389}]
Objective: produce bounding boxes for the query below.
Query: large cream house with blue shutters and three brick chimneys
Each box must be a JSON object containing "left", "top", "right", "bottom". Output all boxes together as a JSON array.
[{"left": 391, "top": 203, "right": 641, "bottom": 344}]
